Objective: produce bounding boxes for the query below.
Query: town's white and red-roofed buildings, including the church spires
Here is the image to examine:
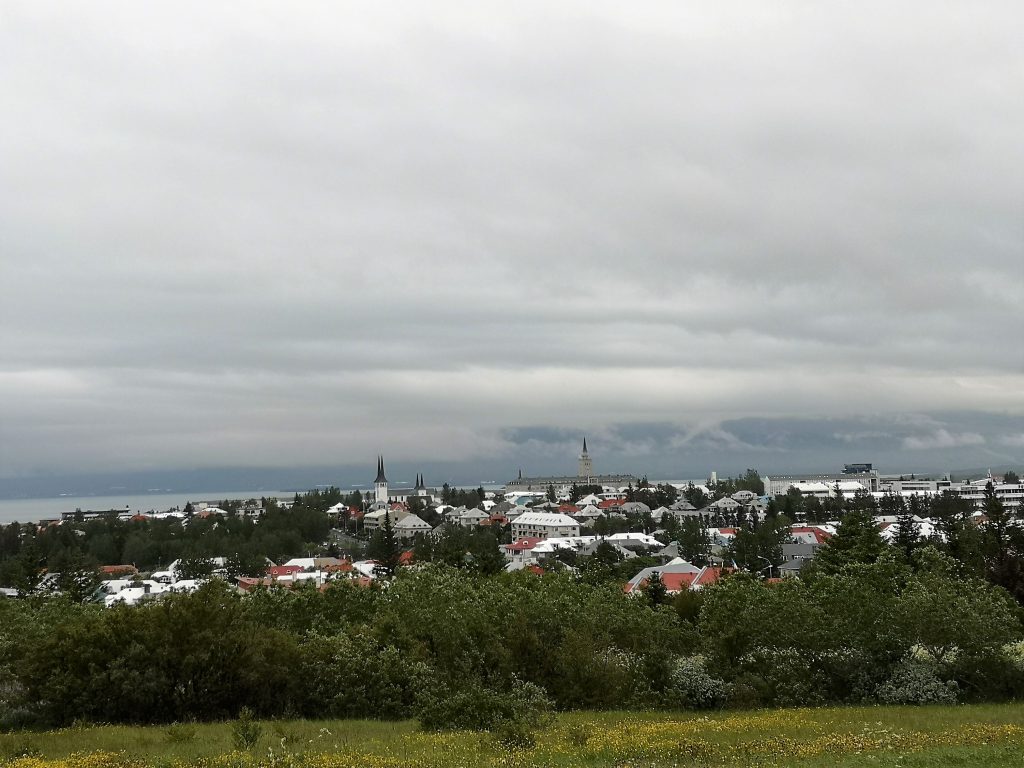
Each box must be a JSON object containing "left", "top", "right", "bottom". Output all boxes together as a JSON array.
[{"left": 12, "top": 443, "right": 1024, "bottom": 605}]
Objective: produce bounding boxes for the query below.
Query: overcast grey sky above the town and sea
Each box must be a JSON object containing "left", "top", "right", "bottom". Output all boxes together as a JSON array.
[{"left": 0, "top": 0, "right": 1024, "bottom": 487}]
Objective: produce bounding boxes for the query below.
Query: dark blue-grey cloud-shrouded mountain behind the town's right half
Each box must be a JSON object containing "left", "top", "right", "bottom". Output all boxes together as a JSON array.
[{"left": 505, "top": 412, "right": 1024, "bottom": 479}]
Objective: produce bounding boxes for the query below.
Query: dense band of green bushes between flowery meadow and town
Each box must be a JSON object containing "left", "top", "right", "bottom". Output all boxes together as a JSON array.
[{"left": 0, "top": 553, "right": 1024, "bottom": 729}]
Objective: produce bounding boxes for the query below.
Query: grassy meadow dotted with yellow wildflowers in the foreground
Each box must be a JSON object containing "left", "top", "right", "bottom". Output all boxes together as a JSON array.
[{"left": 0, "top": 705, "right": 1024, "bottom": 768}]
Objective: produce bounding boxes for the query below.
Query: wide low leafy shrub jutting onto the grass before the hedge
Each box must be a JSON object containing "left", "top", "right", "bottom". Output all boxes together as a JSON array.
[{"left": 417, "top": 679, "right": 551, "bottom": 740}]
